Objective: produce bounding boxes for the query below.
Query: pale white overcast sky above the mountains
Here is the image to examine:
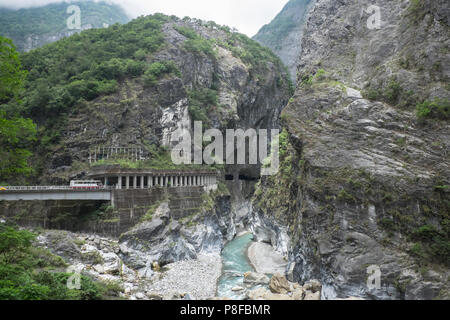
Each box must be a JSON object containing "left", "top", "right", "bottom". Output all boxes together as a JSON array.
[{"left": 0, "top": 0, "right": 288, "bottom": 36}]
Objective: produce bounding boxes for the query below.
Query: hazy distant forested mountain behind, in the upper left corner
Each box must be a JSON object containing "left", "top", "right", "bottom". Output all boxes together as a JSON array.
[{"left": 0, "top": 1, "right": 130, "bottom": 51}]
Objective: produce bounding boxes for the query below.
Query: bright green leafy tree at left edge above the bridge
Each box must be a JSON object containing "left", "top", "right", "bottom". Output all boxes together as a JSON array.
[{"left": 0, "top": 36, "right": 36, "bottom": 181}]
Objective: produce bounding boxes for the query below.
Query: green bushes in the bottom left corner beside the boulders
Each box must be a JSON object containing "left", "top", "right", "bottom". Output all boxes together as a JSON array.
[{"left": 0, "top": 224, "right": 120, "bottom": 300}]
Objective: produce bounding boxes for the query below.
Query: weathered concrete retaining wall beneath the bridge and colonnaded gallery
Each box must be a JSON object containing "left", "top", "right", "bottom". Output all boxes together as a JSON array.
[{"left": 0, "top": 187, "right": 204, "bottom": 237}]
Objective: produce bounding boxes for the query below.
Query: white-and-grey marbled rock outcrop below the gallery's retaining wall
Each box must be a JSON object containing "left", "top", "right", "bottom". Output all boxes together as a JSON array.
[{"left": 120, "top": 190, "right": 236, "bottom": 269}]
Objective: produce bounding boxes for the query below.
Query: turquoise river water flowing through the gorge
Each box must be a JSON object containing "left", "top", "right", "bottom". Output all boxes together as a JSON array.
[{"left": 217, "top": 233, "right": 255, "bottom": 300}]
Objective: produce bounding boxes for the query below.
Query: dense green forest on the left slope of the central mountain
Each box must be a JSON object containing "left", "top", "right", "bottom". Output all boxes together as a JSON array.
[{"left": 17, "top": 15, "right": 167, "bottom": 122}]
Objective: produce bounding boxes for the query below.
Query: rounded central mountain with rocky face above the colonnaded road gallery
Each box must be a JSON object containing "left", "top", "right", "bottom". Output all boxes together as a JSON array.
[{"left": 14, "top": 15, "right": 292, "bottom": 183}]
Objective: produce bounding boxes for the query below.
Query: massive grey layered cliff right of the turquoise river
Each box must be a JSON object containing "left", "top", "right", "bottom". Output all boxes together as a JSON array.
[{"left": 253, "top": 0, "right": 450, "bottom": 299}]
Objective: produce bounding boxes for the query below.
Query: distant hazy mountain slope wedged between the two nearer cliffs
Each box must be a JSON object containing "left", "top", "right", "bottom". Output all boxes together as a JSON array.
[{"left": 253, "top": 0, "right": 312, "bottom": 80}]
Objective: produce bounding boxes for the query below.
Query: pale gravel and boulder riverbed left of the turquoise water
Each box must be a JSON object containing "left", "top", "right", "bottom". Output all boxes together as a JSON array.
[{"left": 36, "top": 230, "right": 222, "bottom": 300}]
